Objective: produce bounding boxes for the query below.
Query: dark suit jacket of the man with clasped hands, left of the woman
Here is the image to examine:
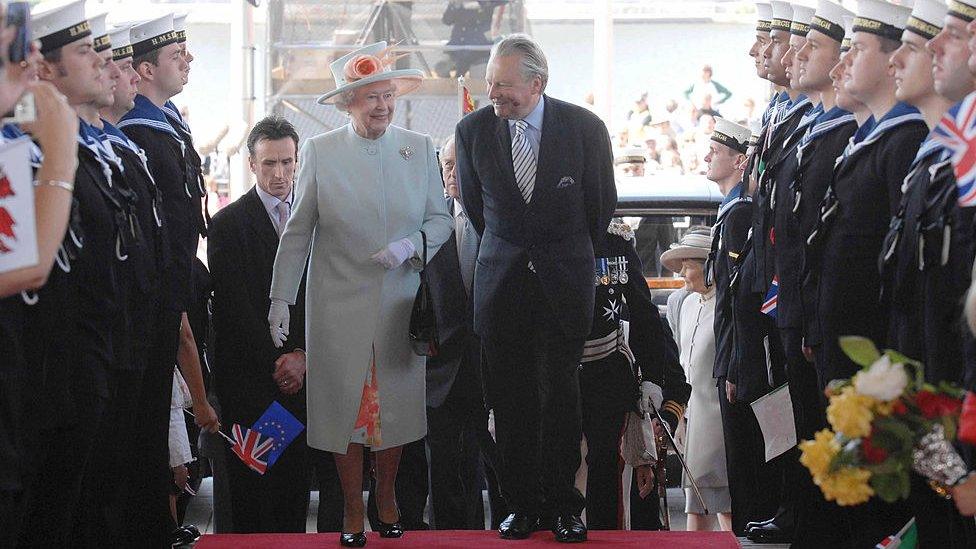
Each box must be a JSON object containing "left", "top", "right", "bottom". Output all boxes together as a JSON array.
[{"left": 207, "top": 188, "right": 305, "bottom": 427}]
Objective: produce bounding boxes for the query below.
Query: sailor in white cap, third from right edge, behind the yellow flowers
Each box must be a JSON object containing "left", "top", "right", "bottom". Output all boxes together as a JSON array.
[{"left": 808, "top": 0, "right": 928, "bottom": 547}]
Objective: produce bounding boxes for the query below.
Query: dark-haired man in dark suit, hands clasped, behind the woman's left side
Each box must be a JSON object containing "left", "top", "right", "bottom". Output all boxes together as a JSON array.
[{"left": 207, "top": 117, "right": 340, "bottom": 533}]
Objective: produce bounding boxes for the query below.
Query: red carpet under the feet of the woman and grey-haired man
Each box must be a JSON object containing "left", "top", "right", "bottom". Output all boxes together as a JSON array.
[{"left": 196, "top": 530, "right": 740, "bottom": 549}]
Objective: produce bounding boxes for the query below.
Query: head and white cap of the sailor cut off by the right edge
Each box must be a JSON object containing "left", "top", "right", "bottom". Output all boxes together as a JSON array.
[{"left": 928, "top": 0, "right": 976, "bottom": 103}]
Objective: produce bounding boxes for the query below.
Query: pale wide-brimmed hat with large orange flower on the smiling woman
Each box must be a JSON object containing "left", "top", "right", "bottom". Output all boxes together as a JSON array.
[{"left": 318, "top": 42, "right": 424, "bottom": 105}]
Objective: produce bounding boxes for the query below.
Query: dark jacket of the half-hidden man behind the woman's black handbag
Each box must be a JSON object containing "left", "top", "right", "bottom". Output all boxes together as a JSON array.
[{"left": 427, "top": 222, "right": 484, "bottom": 408}]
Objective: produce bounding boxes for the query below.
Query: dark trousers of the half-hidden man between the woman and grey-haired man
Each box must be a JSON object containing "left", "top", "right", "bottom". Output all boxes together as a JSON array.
[{"left": 427, "top": 373, "right": 504, "bottom": 530}]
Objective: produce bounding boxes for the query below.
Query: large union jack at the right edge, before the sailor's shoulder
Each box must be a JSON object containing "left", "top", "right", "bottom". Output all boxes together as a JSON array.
[{"left": 932, "top": 93, "right": 976, "bottom": 208}]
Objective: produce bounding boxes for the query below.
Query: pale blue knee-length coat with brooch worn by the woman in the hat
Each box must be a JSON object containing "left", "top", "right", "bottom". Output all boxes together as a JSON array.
[{"left": 271, "top": 124, "right": 453, "bottom": 453}]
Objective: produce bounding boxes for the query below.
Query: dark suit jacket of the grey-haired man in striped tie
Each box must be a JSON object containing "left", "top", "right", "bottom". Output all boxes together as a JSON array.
[{"left": 455, "top": 96, "right": 617, "bottom": 338}]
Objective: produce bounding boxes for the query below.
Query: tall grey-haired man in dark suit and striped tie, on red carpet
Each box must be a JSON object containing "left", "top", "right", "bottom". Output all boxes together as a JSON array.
[{"left": 456, "top": 35, "right": 617, "bottom": 542}]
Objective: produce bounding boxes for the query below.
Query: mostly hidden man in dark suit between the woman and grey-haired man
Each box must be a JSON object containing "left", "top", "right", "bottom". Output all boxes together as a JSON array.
[{"left": 427, "top": 137, "right": 504, "bottom": 530}]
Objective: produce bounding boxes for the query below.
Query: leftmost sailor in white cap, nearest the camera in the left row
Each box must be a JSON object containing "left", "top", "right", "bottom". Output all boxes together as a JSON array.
[{"left": 20, "top": 0, "right": 133, "bottom": 547}]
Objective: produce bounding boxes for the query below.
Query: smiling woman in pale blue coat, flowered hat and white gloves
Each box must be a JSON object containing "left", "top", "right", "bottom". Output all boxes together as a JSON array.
[{"left": 269, "top": 42, "right": 453, "bottom": 546}]
